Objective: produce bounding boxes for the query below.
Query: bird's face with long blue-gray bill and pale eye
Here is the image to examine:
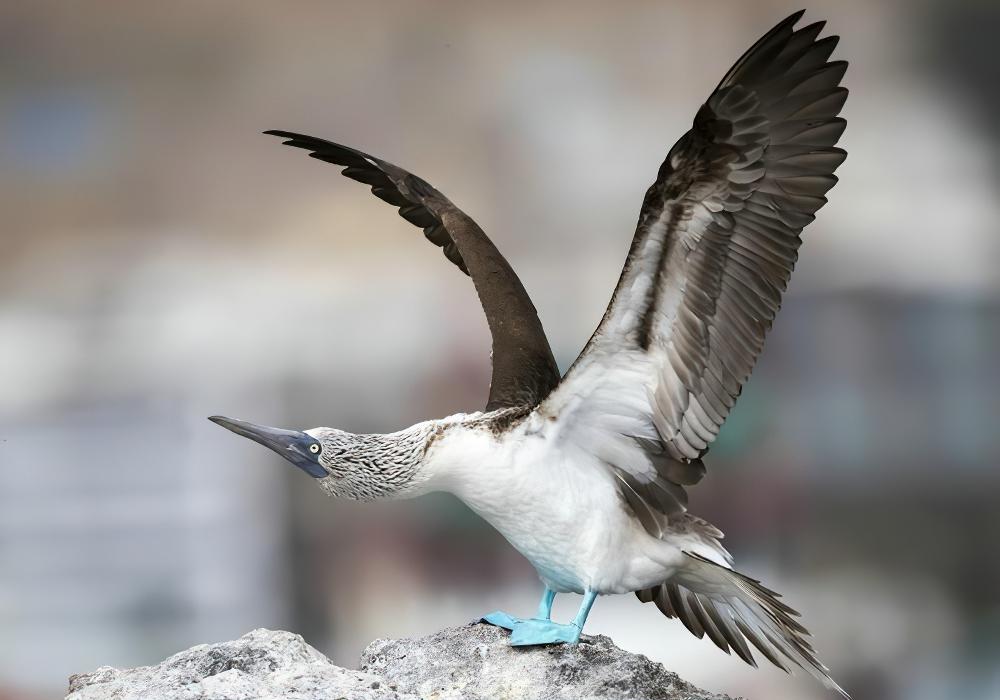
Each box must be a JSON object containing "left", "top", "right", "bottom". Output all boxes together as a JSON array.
[{"left": 209, "top": 416, "right": 348, "bottom": 479}]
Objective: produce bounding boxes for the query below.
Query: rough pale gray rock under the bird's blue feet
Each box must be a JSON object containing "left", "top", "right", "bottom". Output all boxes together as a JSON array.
[{"left": 66, "top": 623, "right": 730, "bottom": 700}]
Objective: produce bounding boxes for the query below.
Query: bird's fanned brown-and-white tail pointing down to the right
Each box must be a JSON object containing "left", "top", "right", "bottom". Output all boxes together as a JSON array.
[{"left": 636, "top": 552, "right": 850, "bottom": 698}]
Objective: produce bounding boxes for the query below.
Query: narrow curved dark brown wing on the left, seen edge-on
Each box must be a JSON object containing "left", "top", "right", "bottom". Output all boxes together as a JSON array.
[{"left": 264, "top": 131, "right": 559, "bottom": 411}]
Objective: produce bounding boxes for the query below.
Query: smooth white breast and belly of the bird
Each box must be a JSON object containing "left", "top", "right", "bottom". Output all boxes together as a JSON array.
[{"left": 426, "top": 424, "right": 680, "bottom": 593}]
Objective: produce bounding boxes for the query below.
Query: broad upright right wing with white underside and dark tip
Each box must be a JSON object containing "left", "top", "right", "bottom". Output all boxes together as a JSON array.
[{"left": 539, "top": 12, "right": 847, "bottom": 531}]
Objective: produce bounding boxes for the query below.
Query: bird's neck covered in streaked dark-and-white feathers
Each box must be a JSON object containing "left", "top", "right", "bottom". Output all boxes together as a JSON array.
[{"left": 320, "top": 422, "right": 435, "bottom": 501}]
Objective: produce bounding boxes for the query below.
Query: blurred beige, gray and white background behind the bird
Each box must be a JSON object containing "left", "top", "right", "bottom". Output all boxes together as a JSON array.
[{"left": 0, "top": 0, "right": 1000, "bottom": 700}]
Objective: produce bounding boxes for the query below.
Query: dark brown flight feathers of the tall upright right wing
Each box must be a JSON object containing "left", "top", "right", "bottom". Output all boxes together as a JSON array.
[{"left": 637, "top": 15, "right": 847, "bottom": 459}]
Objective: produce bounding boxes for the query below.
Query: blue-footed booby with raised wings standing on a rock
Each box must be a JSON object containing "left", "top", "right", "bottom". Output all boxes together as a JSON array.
[{"left": 210, "top": 11, "right": 848, "bottom": 697}]
